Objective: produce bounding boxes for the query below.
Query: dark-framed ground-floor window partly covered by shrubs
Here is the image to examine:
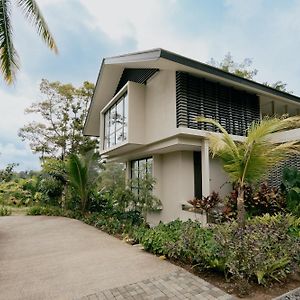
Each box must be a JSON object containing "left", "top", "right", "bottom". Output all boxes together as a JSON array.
[{"left": 131, "top": 157, "right": 153, "bottom": 195}]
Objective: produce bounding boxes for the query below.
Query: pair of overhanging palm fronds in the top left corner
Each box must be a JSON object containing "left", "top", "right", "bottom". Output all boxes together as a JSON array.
[{"left": 0, "top": 0, "right": 57, "bottom": 84}]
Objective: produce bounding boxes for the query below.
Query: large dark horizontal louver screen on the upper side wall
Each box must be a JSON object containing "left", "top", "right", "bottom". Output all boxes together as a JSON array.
[{"left": 176, "top": 72, "right": 260, "bottom": 135}]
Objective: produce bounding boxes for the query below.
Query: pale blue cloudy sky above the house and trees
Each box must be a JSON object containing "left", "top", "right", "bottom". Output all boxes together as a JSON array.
[{"left": 0, "top": 0, "right": 300, "bottom": 170}]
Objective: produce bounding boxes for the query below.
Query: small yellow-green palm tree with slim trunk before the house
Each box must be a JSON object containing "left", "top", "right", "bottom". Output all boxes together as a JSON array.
[{"left": 196, "top": 116, "right": 300, "bottom": 227}]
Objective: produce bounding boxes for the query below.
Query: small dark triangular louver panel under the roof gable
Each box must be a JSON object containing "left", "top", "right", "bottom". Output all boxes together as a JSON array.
[{"left": 115, "top": 68, "right": 158, "bottom": 94}]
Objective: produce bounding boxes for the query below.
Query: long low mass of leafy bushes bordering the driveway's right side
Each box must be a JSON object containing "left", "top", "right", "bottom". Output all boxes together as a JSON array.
[{"left": 137, "top": 214, "right": 300, "bottom": 287}]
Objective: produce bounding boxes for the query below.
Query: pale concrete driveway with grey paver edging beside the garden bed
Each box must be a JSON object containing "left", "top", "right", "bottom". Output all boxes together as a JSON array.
[{"left": 0, "top": 216, "right": 234, "bottom": 300}]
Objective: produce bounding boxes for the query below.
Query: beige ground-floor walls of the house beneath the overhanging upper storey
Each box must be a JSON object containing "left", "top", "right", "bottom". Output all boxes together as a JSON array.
[{"left": 122, "top": 140, "right": 232, "bottom": 225}]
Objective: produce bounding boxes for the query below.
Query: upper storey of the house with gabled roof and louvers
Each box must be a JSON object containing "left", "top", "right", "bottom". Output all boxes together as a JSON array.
[{"left": 85, "top": 49, "right": 300, "bottom": 155}]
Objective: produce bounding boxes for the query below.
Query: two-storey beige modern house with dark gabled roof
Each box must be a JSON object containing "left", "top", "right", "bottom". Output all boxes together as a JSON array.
[{"left": 84, "top": 49, "right": 300, "bottom": 223}]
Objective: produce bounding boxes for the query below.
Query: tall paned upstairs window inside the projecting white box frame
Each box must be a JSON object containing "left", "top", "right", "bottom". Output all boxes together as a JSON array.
[{"left": 104, "top": 93, "right": 128, "bottom": 149}]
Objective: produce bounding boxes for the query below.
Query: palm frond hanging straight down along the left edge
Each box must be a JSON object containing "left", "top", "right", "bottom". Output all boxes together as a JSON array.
[{"left": 0, "top": 0, "right": 19, "bottom": 84}]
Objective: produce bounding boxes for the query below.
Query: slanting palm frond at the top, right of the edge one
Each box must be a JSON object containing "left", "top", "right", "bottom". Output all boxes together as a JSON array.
[{"left": 17, "top": 0, "right": 58, "bottom": 53}]
